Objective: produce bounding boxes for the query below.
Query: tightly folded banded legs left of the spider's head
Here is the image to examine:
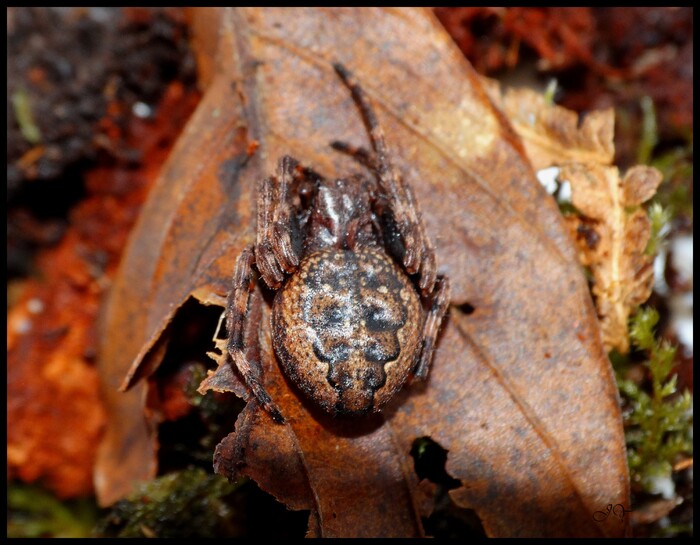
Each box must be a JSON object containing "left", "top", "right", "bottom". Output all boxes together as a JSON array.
[{"left": 255, "top": 155, "right": 299, "bottom": 289}]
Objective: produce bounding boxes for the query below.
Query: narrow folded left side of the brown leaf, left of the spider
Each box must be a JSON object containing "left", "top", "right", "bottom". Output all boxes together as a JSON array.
[{"left": 95, "top": 80, "right": 253, "bottom": 503}]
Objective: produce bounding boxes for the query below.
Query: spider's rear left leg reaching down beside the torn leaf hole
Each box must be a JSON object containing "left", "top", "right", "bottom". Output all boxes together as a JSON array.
[{"left": 226, "top": 245, "right": 284, "bottom": 423}]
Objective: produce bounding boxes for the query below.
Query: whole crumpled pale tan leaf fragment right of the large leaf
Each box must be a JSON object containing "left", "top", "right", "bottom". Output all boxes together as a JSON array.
[{"left": 487, "top": 84, "right": 662, "bottom": 353}]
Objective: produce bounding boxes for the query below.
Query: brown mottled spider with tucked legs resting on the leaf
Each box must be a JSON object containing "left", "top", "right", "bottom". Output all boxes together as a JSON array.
[{"left": 226, "top": 64, "right": 449, "bottom": 422}]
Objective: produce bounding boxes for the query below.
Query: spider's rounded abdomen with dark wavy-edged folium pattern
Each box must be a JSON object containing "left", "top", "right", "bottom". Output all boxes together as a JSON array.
[{"left": 272, "top": 247, "right": 424, "bottom": 415}]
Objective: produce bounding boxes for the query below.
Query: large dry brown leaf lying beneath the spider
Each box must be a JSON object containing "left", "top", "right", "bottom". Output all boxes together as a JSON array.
[{"left": 97, "top": 8, "right": 629, "bottom": 537}]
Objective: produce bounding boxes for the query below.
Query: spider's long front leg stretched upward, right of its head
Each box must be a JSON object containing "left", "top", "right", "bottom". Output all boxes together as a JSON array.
[{"left": 333, "top": 64, "right": 437, "bottom": 293}]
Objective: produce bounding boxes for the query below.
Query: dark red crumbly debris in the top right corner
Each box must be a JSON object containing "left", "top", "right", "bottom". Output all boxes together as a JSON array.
[{"left": 435, "top": 7, "right": 693, "bottom": 144}]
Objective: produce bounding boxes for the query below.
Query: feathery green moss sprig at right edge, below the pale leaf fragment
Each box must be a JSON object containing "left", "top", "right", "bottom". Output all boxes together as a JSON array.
[{"left": 618, "top": 308, "right": 693, "bottom": 493}]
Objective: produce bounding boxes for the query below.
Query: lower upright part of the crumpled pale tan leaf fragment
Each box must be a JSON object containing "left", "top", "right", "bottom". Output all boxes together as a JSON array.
[{"left": 559, "top": 163, "right": 661, "bottom": 354}]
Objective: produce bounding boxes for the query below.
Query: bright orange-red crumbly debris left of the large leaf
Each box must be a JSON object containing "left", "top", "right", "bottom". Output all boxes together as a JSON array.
[{"left": 7, "top": 83, "right": 198, "bottom": 497}]
